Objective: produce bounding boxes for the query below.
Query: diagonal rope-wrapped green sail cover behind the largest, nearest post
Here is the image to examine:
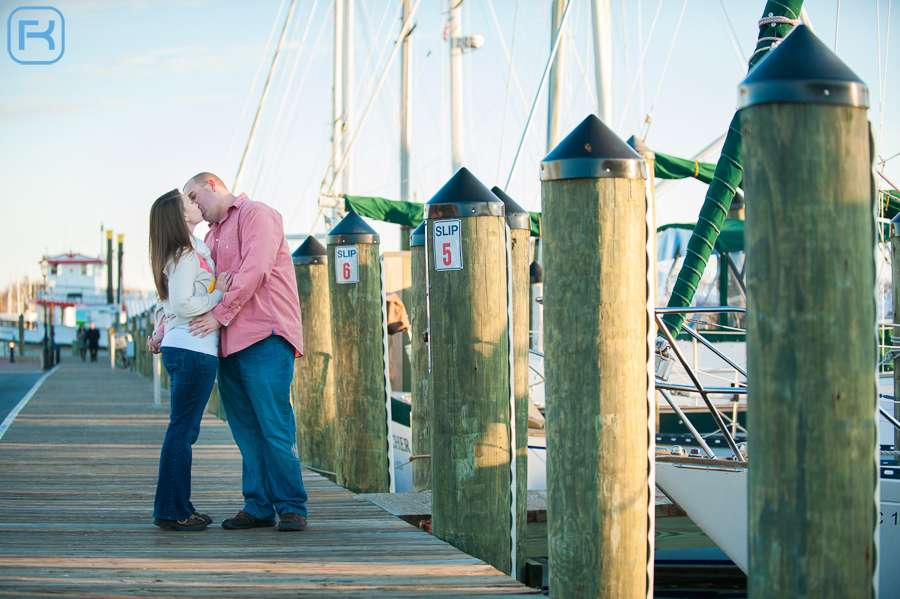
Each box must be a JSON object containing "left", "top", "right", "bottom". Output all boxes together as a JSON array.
[{"left": 663, "top": 0, "right": 803, "bottom": 336}]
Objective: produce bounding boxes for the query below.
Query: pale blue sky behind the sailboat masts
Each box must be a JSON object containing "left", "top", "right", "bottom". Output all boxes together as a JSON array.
[{"left": 0, "top": 0, "right": 900, "bottom": 298}]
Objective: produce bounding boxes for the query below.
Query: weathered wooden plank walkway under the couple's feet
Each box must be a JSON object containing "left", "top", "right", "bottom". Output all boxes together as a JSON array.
[{"left": 0, "top": 359, "right": 539, "bottom": 599}]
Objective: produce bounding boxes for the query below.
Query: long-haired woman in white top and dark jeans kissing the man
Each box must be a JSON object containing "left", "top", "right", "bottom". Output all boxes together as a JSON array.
[{"left": 150, "top": 189, "right": 231, "bottom": 530}]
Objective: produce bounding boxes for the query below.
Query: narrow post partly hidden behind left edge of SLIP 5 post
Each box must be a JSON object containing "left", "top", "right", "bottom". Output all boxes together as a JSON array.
[{"left": 409, "top": 221, "right": 431, "bottom": 492}]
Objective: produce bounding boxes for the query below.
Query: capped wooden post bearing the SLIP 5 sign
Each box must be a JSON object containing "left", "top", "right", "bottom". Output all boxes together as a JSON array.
[{"left": 425, "top": 168, "right": 525, "bottom": 574}]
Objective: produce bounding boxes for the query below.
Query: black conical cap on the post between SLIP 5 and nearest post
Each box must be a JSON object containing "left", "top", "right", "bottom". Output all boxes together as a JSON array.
[{"left": 541, "top": 114, "right": 647, "bottom": 181}]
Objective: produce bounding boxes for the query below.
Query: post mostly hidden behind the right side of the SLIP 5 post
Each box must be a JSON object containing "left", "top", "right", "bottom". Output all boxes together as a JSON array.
[{"left": 491, "top": 187, "right": 531, "bottom": 582}]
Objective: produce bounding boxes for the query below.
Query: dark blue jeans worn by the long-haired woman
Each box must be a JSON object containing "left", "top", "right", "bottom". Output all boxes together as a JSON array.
[{"left": 153, "top": 347, "right": 218, "bottom": 520}]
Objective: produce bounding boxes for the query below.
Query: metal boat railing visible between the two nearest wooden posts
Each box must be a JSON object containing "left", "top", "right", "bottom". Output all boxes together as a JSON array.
[{"left": 656, "top": 306, "right": 747, "bottom": 462}]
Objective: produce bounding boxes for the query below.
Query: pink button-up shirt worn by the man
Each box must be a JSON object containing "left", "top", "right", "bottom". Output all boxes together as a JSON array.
[{"left": 206, "top": 193, "right": 303, "bottom": 356}]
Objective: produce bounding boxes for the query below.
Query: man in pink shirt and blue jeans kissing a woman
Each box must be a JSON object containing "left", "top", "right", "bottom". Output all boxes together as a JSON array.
[{"left": 184, "top": 173, "right": 307, "bottom": 531}]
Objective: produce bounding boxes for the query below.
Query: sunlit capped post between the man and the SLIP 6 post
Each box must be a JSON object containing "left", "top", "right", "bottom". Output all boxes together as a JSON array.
[{"left": 291, "top": 235, "right": 337, "bottom": 472}]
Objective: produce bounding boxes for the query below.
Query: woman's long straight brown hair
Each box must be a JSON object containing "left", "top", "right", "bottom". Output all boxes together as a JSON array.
[{"left": 150, "top": 189, "right": 194, "bottom": 300}]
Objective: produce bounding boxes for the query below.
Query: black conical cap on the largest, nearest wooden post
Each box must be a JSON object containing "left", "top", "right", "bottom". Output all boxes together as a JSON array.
[{"left": 738, "top": 25, "right": 869, "bottom": 108}]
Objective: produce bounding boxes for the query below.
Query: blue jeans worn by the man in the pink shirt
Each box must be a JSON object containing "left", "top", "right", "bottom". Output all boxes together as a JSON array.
[{"left": 219, "top": 335, "right": 307, "bottom": 520}]
